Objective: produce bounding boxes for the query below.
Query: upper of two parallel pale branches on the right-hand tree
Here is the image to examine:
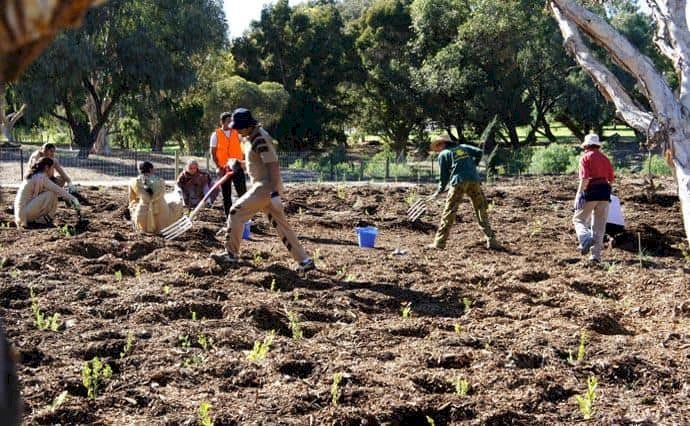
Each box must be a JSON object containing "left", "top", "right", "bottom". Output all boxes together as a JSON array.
[{"left": 550, "top": 0, "right": 680, "bottom": 121}]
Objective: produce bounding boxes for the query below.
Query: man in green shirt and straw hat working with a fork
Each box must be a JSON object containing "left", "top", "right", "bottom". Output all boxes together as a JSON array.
[{"left": 427, "top": 135, "right": 500, "bottom": 249}]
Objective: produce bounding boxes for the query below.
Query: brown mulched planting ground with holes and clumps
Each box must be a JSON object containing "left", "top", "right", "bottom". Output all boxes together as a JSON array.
[{"left": 0, "top": 178, "right": 690, "bottom": 425}]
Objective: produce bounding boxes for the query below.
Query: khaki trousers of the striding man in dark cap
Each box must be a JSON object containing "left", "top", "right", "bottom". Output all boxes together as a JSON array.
[{"left": 225, "top": 182, "right": 307, "bottom": 262}]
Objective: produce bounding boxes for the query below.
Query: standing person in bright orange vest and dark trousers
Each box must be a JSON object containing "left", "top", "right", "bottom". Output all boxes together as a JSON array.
[{"left": 211, "top": 112, "right": 247, "bottom": 218}]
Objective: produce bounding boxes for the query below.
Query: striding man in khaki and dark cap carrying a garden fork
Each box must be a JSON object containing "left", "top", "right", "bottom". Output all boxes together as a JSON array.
[{"left": 212, "top": 108, "right": 315, "bottom": 272}]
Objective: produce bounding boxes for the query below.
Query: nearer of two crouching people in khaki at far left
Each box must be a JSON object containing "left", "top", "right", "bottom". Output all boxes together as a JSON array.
[{"left": 14, "top": 157, "right": 81, "bottom": 227}]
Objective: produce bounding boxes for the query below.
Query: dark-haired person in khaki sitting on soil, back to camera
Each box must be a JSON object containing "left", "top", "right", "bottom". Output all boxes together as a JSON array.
[{"left": 129, "top": 161, "right": 184, "bottom": 234}]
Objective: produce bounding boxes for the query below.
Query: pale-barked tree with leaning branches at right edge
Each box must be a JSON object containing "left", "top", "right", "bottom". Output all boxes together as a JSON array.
[{"left": 549, "top": 0, "right": 690, "bottom": 242}]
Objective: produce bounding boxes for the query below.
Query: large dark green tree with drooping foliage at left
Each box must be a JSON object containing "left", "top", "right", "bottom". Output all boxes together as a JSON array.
[{"left": 19, "top": 0, "right": 226, "bottom": 156}]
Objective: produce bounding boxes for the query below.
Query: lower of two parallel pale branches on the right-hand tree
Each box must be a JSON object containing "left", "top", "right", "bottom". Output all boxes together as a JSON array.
[{"left": 551, "top": 1, "right": 656, "bottom": 133}]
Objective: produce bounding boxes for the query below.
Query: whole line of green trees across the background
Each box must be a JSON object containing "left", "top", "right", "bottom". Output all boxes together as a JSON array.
[{"left": 0, "top": 0, "right": 677, "bottom": 156}]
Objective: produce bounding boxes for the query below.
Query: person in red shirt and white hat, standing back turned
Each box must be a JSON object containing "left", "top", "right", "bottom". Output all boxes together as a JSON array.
[{"left": 573, "top": 133, "right": 614, "bottom": 262}]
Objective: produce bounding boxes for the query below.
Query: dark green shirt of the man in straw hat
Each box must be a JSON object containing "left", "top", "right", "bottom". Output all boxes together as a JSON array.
[{"left": 438, "top": 144, "right": 482, "bottom": 192}]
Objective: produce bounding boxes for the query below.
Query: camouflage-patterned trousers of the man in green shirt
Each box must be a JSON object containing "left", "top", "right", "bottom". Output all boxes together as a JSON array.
[{"left": 434, "top": 182, "right": 495, "bottom": 248}]
